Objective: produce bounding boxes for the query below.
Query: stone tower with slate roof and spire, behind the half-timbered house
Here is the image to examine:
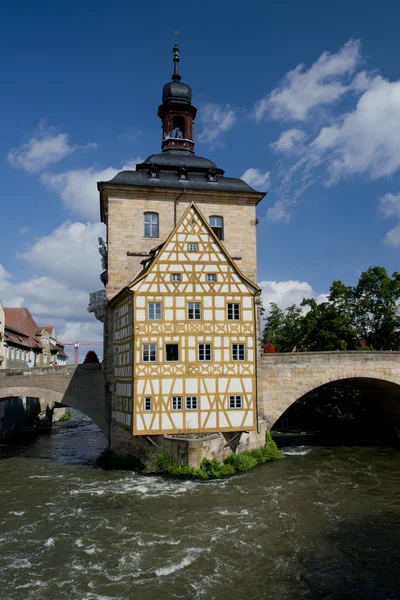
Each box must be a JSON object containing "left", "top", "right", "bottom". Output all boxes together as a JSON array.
[{"left": 98, "top": 44, "right": 265, "bottom": 454}]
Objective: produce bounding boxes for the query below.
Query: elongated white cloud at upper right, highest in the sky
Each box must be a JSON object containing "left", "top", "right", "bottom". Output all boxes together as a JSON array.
[{"left": 254, "top": 40, "right": 361, "bottom": 121}]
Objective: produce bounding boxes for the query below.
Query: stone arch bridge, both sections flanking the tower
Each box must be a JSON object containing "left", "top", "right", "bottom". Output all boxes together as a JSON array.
[{"left": 0, "top": 351, "right": 400, "bottom": 439}]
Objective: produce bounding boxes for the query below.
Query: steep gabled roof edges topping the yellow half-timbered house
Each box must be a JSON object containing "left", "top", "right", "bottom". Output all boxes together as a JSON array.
[{"left": 109, "top": 203, "right": 261, "bottom": 304}]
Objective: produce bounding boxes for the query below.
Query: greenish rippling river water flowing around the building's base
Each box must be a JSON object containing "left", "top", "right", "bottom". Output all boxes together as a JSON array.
[{"left": 0, "top": 415, "right": 400, "bottom": 600}]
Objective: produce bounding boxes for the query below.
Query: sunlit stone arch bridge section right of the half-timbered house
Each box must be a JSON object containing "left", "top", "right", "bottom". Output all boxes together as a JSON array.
[{"left": 260, "top": 351, "right": 400, "bottom": 428}]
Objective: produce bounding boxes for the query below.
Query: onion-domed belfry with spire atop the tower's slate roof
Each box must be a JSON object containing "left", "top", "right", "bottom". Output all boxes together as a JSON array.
[{"left": 157, "top": 42, "right": 197, "bottom": 152}]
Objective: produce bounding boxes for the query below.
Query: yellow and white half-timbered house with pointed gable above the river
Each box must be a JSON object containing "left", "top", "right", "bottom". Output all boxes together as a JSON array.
[{"left": 113, "top": 204, "right": 259, "bottom": 435}]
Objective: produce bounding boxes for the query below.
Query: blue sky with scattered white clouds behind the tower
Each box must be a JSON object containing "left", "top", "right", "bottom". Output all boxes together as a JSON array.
[{"left": 0, "top": 0, "right": 400, "bottom": 354}]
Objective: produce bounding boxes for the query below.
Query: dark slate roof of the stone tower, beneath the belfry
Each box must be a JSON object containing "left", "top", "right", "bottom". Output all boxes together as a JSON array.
[{"left": 104, "top": 150, "right": 257, "bottom": 193}]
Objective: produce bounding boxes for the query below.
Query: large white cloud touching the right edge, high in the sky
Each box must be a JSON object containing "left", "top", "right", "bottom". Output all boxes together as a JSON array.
[{"left": 312, "top": 75, "right": 400, "bottom": 184}]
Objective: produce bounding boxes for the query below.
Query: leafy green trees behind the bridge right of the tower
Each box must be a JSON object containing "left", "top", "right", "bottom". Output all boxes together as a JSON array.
[{"left": 263, "top": 267, "right": 400, "bottom": 352}]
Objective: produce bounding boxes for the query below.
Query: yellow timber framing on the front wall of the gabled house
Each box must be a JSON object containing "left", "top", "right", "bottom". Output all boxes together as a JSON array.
[{"left": 110, "top": 204, "right": 260, "bottom": 435}]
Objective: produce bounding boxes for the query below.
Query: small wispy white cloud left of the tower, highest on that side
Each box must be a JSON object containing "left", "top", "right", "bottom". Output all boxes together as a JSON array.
[{"left": 7, "top": 122, "right": 97, "bottom": 173}]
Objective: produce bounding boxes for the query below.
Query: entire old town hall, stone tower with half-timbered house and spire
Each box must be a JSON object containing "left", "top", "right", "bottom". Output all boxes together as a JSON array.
[{"left": 98, "top": 44, "right": 265, "bottom": 454}]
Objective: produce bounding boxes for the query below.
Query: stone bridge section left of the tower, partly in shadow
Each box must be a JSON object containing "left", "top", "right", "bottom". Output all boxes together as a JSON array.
[{"left": 0, "top": 364, "right": 111, "bottom": 439}]
